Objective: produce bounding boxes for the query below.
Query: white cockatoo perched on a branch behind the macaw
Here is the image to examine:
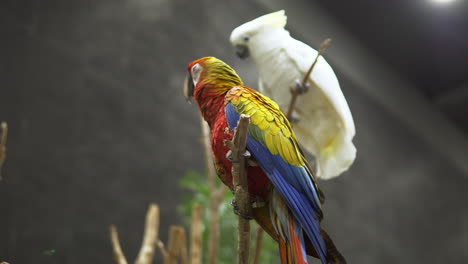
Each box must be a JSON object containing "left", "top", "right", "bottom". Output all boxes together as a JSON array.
[{"left": 231, "top": 10, "right": 356, "bottom": 179}]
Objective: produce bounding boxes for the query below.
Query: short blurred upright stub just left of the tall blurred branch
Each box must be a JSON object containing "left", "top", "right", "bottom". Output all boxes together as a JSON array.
[{"left": 190, "top": 204, "right": 203, "bottom": 264}]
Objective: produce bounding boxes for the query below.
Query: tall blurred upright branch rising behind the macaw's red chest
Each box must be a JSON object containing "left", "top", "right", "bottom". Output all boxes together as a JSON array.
[{"left": 201, "top": 119, "right": 225, "bottom": 264}]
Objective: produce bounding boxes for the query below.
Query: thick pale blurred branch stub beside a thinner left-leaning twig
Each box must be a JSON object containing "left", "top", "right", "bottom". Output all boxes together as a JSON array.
[{"left": 135, "top": 203, "right": 159, "bottom": 264}]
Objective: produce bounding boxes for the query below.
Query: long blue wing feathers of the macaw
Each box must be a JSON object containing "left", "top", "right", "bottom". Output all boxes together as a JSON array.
[{"left": 225, "top": 103, "right": 327, "bottom": 263}]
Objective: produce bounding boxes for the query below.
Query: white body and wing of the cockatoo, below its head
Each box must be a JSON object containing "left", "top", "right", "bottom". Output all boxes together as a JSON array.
[{"left": 252, "top": 36, "right": 356, "bottom": 179}]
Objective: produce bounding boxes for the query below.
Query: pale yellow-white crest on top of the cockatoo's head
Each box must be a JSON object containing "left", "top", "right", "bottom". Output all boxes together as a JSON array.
[{"left": 231, "top": 10, "right": 287, "bottom": 43}]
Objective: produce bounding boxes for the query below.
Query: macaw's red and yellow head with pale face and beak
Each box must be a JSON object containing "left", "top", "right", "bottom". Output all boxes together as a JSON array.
[{"left": 184, "top": 57, "right": 242, "bottom": 104}]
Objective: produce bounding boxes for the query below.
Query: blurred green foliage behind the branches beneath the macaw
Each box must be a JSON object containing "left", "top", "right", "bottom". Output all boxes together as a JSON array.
[{"left": 179, "top": 171, "right": 280, "bottom": 264}]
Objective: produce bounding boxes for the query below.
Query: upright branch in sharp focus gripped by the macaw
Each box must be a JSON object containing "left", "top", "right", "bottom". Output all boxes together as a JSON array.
[{"left": 224, "top": 114, "right": 252, "bottom": 264}]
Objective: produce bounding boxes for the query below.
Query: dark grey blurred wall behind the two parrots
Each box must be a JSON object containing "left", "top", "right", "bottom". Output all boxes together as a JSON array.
[{"left": 0, "top": 0, "right": 468, "bottom": 264}]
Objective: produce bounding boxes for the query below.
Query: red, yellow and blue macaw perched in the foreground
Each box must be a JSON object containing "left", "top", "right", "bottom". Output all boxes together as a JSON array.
[{"left": 184, "top": 57, "right": 346, "bottom": 264}]
